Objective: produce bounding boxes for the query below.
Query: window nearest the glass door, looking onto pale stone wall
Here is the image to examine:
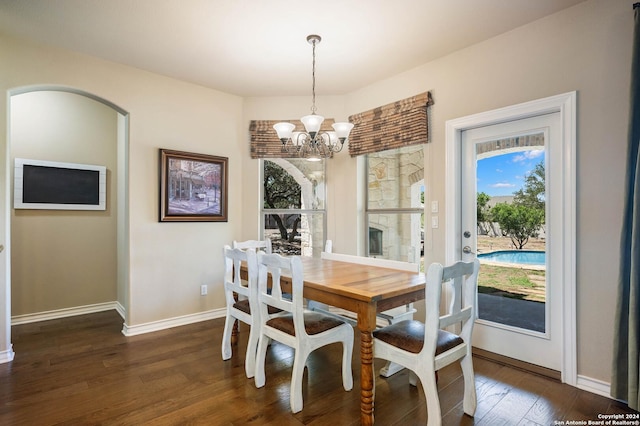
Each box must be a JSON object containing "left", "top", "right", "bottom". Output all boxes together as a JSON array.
[{"left": 364, "top": 145, "right": 424, "bottom": 263}]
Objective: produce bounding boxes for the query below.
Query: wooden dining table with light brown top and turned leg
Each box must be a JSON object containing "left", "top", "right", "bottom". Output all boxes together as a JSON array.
[{"left": 241, "top": 256, "right": 426, "bottom": 425}]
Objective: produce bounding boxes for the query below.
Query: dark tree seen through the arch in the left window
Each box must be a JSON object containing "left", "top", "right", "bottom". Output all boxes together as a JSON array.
[{"left": 263, "top": 160, "right": 302, "bottom": 242}]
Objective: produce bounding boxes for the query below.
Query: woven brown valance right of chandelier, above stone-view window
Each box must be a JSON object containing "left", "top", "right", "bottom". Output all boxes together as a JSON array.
[{"left": 348, "top": 92, "right": 433, "bottom": 157}]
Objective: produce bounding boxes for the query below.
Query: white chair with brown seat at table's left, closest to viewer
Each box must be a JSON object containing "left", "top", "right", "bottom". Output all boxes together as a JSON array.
[{"left": 255, "top": 253, "right": 354, "bottom": 413}]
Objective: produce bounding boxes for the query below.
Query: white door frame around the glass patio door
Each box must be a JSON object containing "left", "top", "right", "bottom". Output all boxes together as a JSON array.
[{"left": 445, "top": 92, "right": 577, "bottom": 386}]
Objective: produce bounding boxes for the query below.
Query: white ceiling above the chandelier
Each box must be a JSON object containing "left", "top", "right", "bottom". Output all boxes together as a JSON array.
[{"left": 0, "top": 0, "right": 584, "bottom": 96}]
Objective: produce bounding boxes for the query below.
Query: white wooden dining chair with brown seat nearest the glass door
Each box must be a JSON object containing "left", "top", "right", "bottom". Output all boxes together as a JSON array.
[{"left": 373, "top": 259, "right": 480, "bottom": 426}]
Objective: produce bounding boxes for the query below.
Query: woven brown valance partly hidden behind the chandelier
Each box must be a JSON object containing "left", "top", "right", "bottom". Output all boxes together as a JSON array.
[{"left": 249, "top": 118, "right": 335, "bottom": 158}]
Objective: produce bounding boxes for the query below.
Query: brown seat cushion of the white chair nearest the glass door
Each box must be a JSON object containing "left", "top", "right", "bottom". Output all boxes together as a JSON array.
[{"left": 373, "top": 320, "right": 464, "bottom": 355}]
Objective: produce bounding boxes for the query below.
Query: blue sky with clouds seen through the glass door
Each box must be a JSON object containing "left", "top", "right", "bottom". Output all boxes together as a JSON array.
[{"left": 476, "top": 150, "right": 544, "bottom": 197}]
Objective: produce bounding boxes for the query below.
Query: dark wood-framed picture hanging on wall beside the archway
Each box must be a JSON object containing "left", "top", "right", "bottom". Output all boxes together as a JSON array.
[{"left": 160, "top": 149, "right": 228, "bottom": 222}]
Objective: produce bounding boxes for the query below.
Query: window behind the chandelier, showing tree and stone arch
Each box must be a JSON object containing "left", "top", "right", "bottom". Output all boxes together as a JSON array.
[{"left": 261, "top": 158, "right": 327, "bottom": 257}]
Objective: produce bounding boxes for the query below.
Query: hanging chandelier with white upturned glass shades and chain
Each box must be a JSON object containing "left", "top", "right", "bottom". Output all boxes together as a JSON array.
[{"left": 273, "top": 34, "right": 353, "bottom": 161}]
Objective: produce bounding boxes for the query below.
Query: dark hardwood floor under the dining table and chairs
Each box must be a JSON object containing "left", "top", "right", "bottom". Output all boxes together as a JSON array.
[{"left": 0, "top": 311, "right": 637, "bottom": 426}]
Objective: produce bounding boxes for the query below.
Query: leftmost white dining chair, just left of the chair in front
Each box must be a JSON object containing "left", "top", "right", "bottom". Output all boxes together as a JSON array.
[{"left": 222, "top": 245, "right": 260, "bottom": 378}]
